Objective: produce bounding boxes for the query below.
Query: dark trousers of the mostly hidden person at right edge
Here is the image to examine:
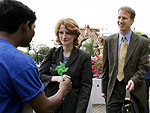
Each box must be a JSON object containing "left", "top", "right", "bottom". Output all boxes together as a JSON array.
[{"left": 145, "top": 79, "right": 150, "bottom": 113}]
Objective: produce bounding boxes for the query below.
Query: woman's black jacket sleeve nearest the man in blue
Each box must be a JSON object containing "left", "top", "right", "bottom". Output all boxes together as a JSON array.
[{"left": 39, "top": 48, "right": 55, "bottom": 86}]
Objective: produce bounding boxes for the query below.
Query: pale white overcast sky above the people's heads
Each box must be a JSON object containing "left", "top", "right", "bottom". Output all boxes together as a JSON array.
[{"left": 19, "top": 0, "right": 150, "bottom": 47}]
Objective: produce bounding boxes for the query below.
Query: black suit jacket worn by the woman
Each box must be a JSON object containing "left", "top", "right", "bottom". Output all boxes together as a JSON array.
[{"left": 39, "top": 47, "right": 93, "bottom": 113}]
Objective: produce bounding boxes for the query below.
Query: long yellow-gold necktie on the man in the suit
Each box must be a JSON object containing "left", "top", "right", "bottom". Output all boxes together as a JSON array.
[{"left": 117, "top": 36, "right": 127, "bottom": 81}]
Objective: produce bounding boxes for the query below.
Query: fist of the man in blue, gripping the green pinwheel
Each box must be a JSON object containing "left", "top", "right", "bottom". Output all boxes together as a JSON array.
[{"left": 59, "top": 75, "right": 72, "bottom": 96}]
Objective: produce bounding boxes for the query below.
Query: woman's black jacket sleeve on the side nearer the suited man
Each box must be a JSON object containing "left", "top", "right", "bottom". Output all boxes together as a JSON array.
[{"left": 76, "top": 55, "right": 93, "bottom": 113}]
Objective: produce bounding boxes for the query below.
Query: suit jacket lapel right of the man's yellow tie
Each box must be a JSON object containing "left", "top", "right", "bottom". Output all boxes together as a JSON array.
[{"left": 125, "top": 33, "right": 138, "bottom": 66}]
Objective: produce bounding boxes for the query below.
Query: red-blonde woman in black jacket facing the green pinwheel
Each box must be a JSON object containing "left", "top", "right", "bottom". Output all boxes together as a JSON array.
[{"left": 39, "top": 18, "right": 93, "bottom": 113}]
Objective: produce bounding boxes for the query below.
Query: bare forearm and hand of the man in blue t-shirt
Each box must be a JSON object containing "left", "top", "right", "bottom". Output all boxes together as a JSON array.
[{"left": 29, "top": 76, "right": 72, "bottom": 113}]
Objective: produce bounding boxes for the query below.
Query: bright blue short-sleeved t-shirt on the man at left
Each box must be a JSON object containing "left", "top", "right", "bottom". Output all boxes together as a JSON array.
[{"left": 0, "top": 38, "right": 45, "bottom": 113}]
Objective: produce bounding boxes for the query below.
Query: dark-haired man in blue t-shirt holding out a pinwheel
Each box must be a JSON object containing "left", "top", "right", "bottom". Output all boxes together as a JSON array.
[{"left": 0, "top": 0, "right": 72, "bottom": 113}]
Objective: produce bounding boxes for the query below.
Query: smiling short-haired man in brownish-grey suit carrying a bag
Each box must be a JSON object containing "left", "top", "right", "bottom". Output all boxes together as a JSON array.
[{"left": 102, "top": 6, "right": 149, "bottom": 113}]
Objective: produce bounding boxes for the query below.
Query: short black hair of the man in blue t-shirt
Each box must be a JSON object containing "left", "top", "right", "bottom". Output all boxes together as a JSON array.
[{"left": 0, "top": 0, "right": 36, "bottom": 33}]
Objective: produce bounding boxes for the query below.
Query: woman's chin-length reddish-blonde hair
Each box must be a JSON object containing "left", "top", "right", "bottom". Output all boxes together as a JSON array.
[{"left": 55, "top": 18, "right": 80, "bottom": 46}]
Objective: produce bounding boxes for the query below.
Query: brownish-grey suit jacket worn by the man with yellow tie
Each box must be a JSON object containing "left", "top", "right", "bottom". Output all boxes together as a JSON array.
[{"left": 102, "top": 33, "right": 149, "bottom": 106}]
